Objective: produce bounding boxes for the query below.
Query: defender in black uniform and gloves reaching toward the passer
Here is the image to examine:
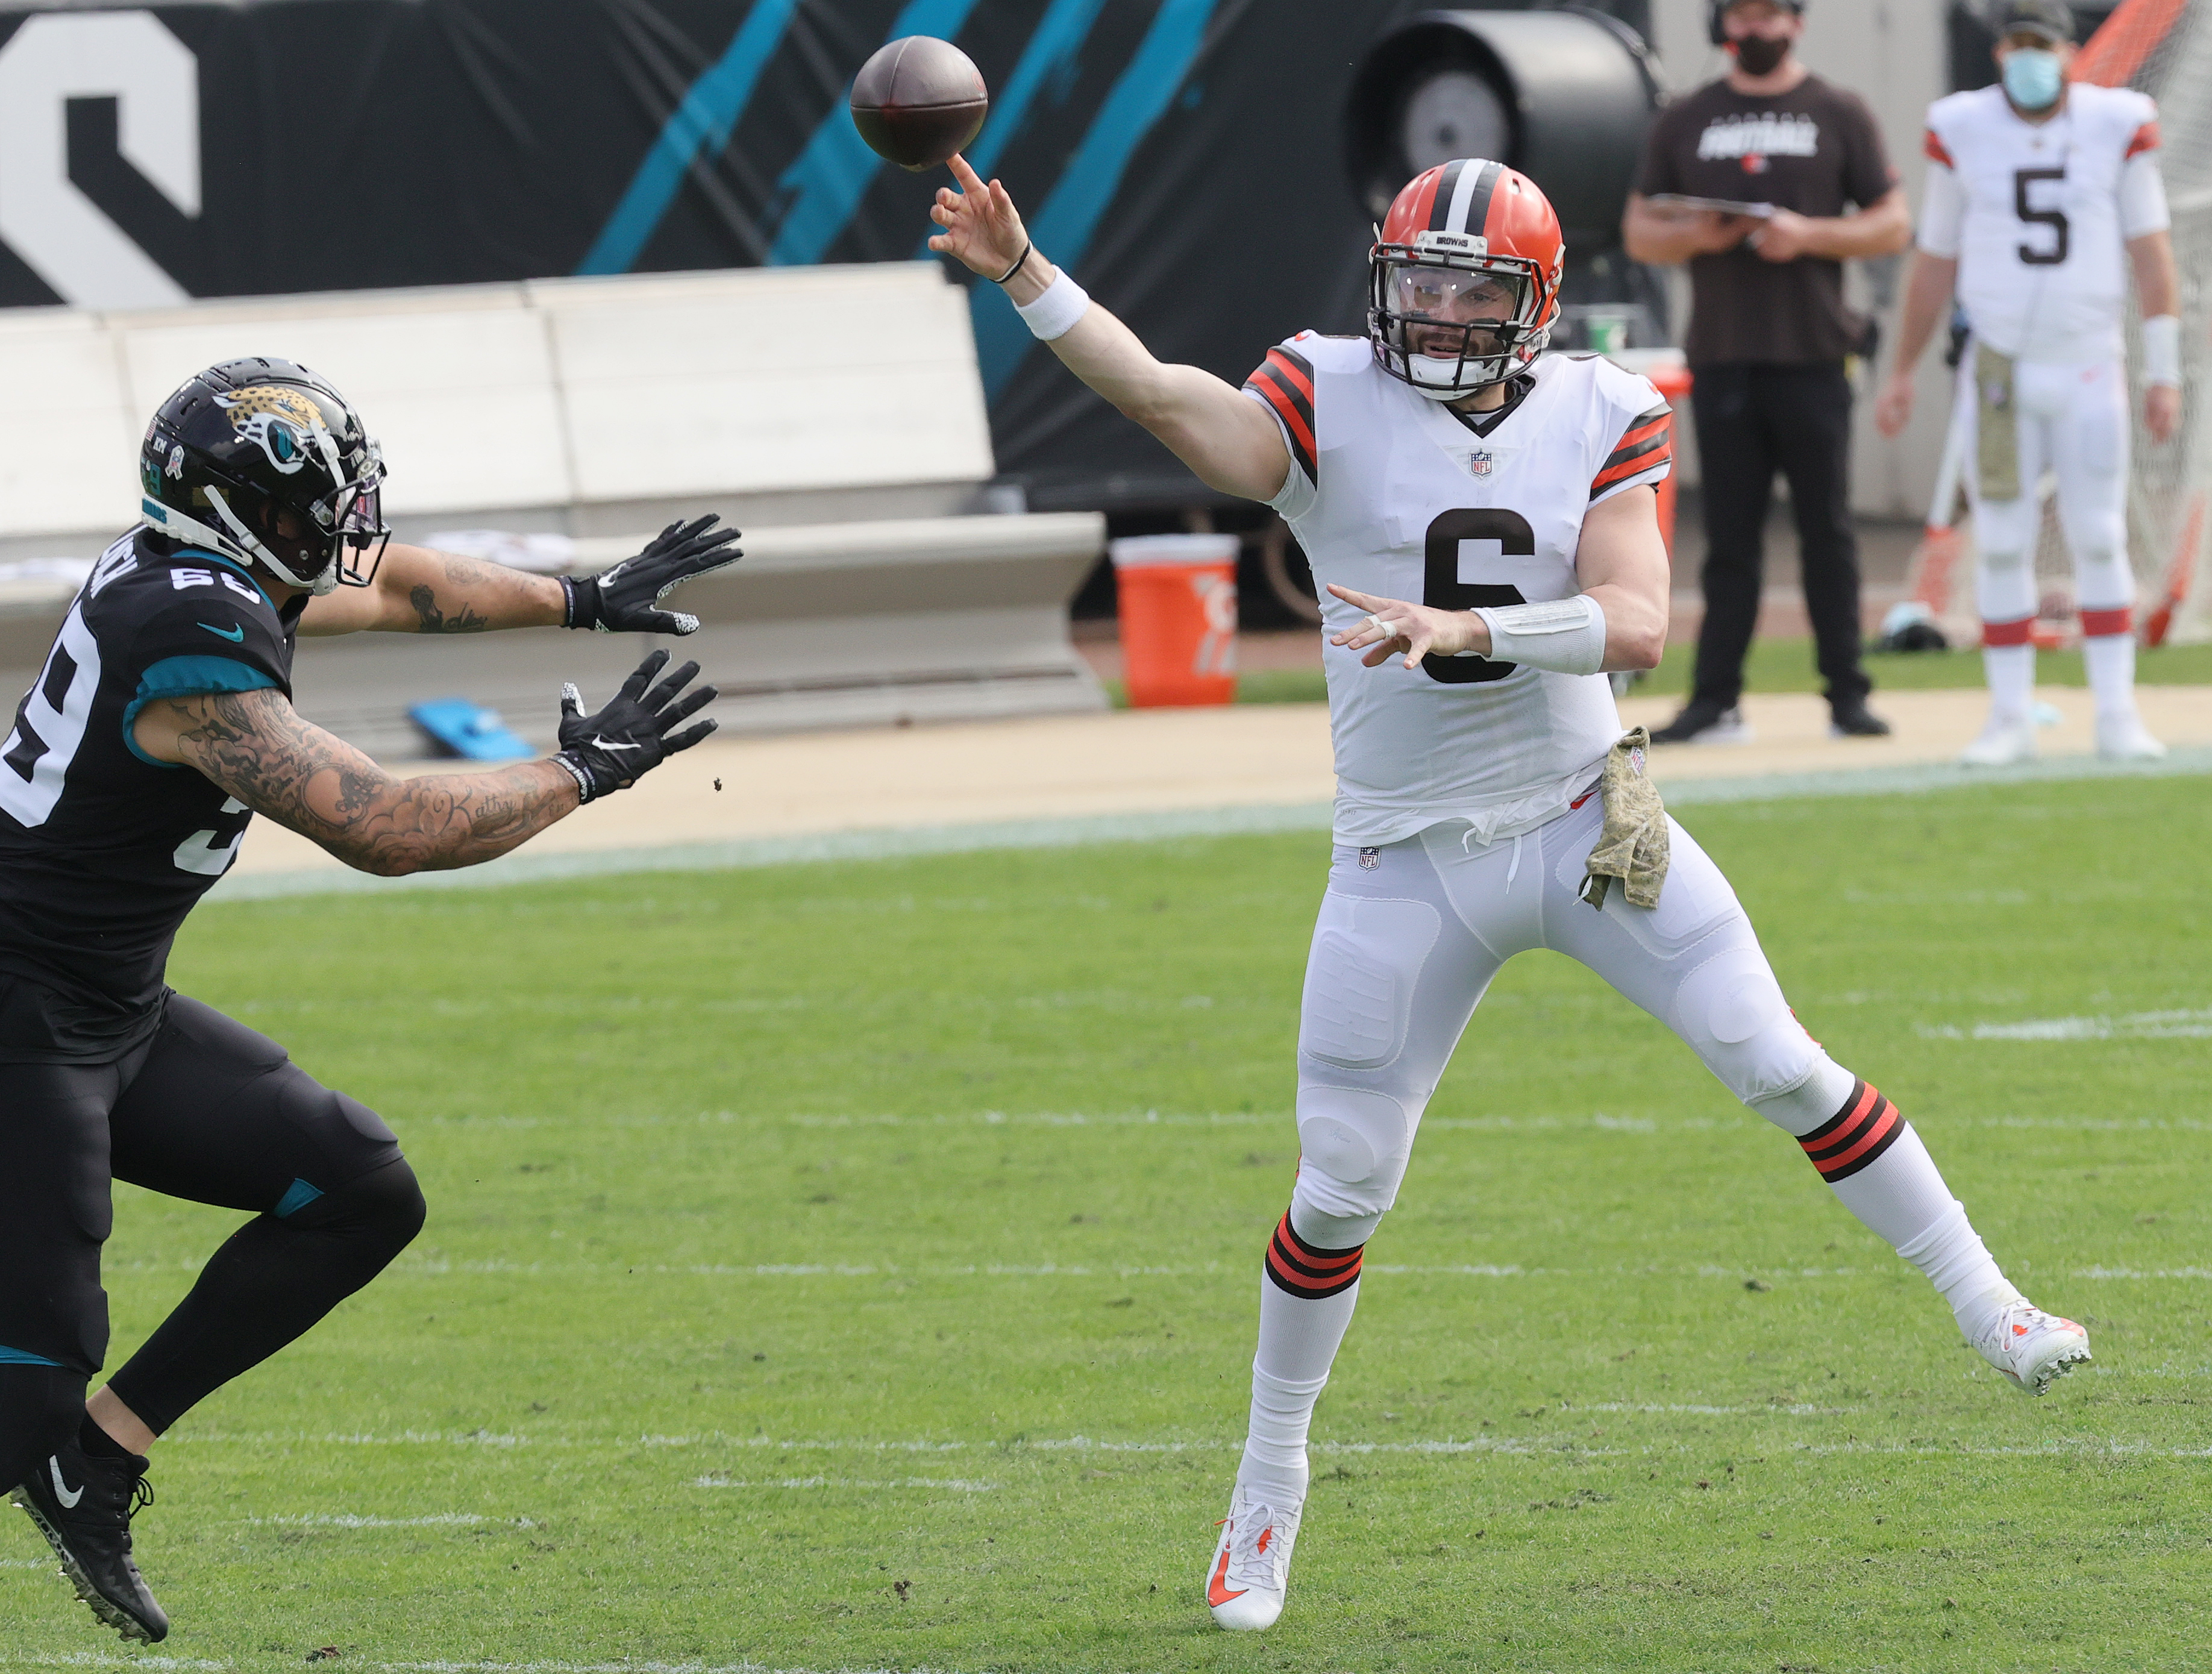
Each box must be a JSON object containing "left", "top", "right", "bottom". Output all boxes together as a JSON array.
[{"left": 0, "top": 360, "right": 739, "bottom": 1641}]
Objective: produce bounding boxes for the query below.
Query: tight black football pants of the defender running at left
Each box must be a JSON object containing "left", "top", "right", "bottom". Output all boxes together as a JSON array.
[{"left": 0, "top": 995, "right": 422, "bottom": 1490}]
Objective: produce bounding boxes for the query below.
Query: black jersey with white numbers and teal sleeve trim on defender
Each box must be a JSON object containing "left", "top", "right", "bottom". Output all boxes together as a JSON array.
[{"left": 0, "top": 528, "right": 307, "bottom": 1057}]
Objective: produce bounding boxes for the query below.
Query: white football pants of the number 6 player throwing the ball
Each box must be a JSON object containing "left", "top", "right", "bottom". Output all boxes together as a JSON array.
[{"left": 1289, "top": 794, "right": 1858, "bottom": 1249}]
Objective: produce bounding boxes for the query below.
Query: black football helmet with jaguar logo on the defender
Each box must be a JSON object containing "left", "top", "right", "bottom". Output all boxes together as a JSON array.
[{"left": 139, "top": 356, "right": 392, "bottom": 592}]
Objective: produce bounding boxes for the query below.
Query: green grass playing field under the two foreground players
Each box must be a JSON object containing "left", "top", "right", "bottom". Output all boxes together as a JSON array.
[{"left": 0, "top": 779, "right": 2212, "bottom": 1674}]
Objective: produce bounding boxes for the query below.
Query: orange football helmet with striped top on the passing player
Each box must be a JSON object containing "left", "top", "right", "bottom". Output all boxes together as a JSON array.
[{"left": 1367, "top": 157, "right": 1566, "bottom": 400}]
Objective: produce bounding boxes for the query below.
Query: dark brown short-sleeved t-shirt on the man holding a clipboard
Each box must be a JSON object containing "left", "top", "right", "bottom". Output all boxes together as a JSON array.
[{"left": 1637, "top": 75, "right": 1898, "bottom": 367}]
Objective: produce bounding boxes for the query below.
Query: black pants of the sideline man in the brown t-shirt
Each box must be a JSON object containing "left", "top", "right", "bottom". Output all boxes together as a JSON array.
[{"left": 1690, "top": 363, "right": 1873, "bottom": 707}]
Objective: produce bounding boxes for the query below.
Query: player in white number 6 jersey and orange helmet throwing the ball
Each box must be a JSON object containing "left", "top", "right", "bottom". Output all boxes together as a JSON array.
[{"left": 931, "top": 157, "right": 2088, "bottom": 1628}]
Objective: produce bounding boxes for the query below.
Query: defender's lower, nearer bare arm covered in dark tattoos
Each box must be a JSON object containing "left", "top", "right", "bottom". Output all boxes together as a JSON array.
[{"left": 133, "top": 690, "right": 580, "bottom": 878}]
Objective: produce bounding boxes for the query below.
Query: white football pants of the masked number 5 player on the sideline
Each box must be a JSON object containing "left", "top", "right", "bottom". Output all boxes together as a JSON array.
[{"left": 1958, "top": 358, "right": 2135, "bottom": 646}]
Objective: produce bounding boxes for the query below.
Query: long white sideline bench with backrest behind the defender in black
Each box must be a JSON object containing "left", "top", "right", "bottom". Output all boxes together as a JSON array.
[{"left": 0, "top": 263, "right": 1104, "bottom": 754}]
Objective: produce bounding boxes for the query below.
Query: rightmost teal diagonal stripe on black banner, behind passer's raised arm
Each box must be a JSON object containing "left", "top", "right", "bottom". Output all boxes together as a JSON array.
[{"left": 969, "top": 0, "right": 1219, "bottom": 396}]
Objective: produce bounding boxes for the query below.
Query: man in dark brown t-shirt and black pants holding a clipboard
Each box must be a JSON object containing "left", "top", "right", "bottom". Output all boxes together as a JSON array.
[{"left": 1621, "top": 0, "right": 1911, "bottom": 743}]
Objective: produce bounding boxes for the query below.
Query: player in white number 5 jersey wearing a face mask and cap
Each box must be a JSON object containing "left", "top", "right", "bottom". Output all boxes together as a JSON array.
[{"left": 1876, "top": 0, "right": 2181, "bottom": 765}]
